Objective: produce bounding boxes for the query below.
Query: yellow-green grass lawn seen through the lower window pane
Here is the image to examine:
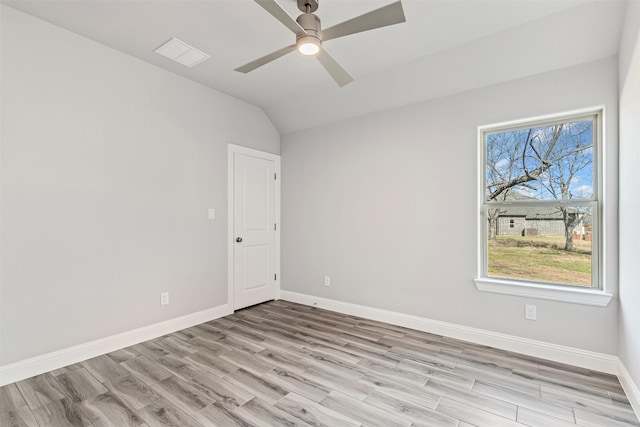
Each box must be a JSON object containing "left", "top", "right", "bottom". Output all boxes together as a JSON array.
[{"left": 489, "top": 236, "right": 591, "bottom": 286}]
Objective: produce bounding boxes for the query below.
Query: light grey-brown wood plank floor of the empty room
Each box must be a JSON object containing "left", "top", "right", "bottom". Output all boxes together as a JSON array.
[{"left": 0, "top": 301, "right": 640, "bottom": 427}]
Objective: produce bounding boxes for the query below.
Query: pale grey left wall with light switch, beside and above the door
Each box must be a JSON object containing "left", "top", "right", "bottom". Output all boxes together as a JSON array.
[{"left": 0, "top": 6, "right": 279, "bottom": 365}]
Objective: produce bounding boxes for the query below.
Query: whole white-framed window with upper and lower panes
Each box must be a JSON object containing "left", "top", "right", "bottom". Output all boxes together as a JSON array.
[{"left": 476, "top": 112, "right": 602, "bottom": 299}]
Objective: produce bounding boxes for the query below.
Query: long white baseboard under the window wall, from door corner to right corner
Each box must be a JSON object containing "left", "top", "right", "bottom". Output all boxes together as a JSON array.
[{"left": 282, "top": 291, "right": 619, "bottom": 374}]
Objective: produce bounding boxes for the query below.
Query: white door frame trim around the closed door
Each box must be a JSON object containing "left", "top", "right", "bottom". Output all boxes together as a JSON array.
[{"left": 227, "top": 143, "right": 281, "bottom": 311}]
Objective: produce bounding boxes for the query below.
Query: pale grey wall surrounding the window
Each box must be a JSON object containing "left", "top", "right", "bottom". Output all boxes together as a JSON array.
[{"left": 282, "top": 58, "right": 618, "bottom": 354}]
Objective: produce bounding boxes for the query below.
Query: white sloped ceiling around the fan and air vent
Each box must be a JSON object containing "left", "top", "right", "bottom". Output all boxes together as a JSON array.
[{"left": 2, "top": 0, "right": 636, "bottom": 133}]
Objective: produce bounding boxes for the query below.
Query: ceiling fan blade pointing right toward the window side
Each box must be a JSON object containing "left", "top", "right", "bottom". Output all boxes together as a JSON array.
[{"left": 322, "top": 0, "right": 406, "bottom": 42}]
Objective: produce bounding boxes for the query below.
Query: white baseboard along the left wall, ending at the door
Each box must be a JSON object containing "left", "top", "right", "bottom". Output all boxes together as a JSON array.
[{"left": 0, "top": 304, "right": 233, "bottom": 387}]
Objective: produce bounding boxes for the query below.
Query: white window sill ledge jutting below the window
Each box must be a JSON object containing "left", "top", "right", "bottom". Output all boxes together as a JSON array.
[{"left": 474, "top": 277, "right": 613, "bottom": 307}]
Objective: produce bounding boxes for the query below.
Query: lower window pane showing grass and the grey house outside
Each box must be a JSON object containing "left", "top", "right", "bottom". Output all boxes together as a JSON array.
[{"left": 486, "top": 205, "right": 592, "bottom": 286}]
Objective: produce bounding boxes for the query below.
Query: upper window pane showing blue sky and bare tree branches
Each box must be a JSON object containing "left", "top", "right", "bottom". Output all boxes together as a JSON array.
[{"left": 485, "top": 120, "right": 594, "bottom": 202}]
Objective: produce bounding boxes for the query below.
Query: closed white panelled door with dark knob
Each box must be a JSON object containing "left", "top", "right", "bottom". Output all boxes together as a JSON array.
[{"left": 232, "top": 152, "right": 277, "bottom": 310}]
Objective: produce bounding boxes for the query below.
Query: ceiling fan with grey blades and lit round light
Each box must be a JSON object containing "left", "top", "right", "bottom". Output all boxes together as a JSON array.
[{"left": 235, "top": 0, "right": 405, "bottom": 87}]
